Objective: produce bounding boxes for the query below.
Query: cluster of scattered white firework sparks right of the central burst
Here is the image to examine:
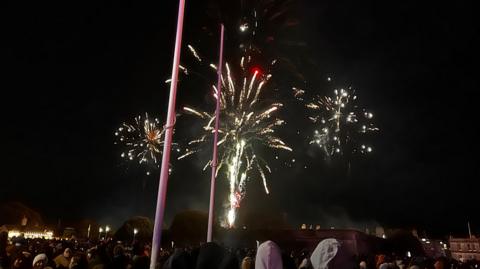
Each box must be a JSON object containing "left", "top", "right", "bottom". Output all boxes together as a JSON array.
[{"left": 308, "top": 84, "right": 378, "bottom": 158}]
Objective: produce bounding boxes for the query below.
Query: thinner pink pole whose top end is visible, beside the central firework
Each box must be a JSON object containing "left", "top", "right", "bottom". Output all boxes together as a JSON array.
[{"left": 207, "top": 24, "right": 224, "bottom": 242}]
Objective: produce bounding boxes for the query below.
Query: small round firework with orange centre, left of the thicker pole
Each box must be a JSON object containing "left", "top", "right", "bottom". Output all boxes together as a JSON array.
[{"left": 115, "top": 113, "right": 178, "bottom": 175}]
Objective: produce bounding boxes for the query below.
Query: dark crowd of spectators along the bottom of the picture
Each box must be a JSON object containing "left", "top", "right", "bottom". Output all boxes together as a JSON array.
[{"left": 0, "top": 238, "right": 479, "bottom": 269}]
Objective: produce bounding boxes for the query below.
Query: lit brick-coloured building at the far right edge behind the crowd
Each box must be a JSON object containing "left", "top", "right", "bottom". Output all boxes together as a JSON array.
[{"left": 449, "top": 236, "right": 480, "bottom": 261}]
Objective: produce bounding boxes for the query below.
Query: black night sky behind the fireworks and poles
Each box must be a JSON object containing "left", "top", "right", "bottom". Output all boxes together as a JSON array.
[{"left": 0, "top": 0, "right": 480, "bottom": 235}]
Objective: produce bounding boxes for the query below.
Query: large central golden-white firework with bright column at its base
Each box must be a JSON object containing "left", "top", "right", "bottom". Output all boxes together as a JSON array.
[{"left": 179, "top": 53, "right": 292, "bottom": 227}]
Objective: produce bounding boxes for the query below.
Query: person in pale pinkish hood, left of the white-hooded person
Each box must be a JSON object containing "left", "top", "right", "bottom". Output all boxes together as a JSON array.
[{"left": 255, "top": 240, "right": 283, "bottom": 269}]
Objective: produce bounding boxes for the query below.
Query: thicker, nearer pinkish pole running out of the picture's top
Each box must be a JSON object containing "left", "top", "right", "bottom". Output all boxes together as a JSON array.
[{"left": 150, "top": 0, "right": 185, "bottom": 269}]
